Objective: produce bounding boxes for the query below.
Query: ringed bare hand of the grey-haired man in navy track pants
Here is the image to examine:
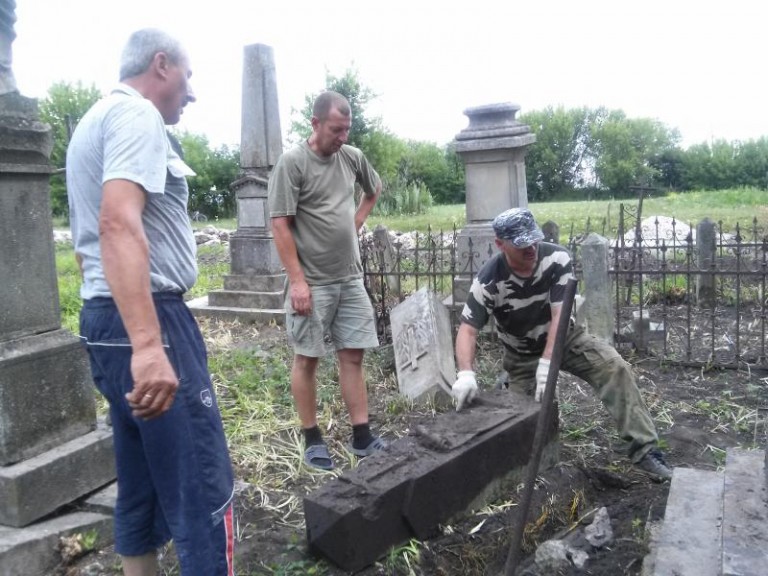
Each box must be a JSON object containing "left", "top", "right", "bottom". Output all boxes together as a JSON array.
[{"left": 125, "top": 346, "right": 179, "bottom": 420}]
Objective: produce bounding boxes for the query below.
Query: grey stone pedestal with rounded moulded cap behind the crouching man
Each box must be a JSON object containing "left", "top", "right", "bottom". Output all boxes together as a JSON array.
[{"left": 453, "top": 103, "right": 536, "bottom": 304}]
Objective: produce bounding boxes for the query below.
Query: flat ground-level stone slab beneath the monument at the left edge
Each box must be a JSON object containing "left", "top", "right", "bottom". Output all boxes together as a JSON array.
[{"left": 0, "top": 512, "right": 113, "bottom": 576}]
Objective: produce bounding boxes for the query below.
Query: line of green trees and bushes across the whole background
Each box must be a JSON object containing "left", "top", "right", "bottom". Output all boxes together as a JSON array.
[{"left": 40, "top": 69, "right": 768, "bottom": 219}]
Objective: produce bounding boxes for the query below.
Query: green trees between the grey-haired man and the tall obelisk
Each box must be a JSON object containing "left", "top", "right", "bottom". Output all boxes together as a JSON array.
[{"left": 178, "top": 132, "right": 240, "bottom": 219}]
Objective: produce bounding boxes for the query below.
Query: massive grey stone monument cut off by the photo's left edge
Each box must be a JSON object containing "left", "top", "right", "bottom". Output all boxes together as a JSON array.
[{"left": 0, "top": 0, "right": 115, "bottom": 574}]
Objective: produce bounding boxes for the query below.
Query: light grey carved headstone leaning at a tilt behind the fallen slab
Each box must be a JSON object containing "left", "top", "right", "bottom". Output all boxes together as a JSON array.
[{"left": 391, "top": 288, "right": 456, "bottom": 401}]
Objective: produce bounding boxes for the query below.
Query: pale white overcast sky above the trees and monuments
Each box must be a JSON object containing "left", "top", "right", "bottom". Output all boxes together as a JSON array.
[{"left": 13, "top": 0, "right": 768, "bottom": 146}]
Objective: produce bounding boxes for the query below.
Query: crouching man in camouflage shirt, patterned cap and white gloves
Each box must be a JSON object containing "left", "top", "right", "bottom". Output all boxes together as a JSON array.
[{"left": 453, "top": 208, "right": 672, "bottom": 480}]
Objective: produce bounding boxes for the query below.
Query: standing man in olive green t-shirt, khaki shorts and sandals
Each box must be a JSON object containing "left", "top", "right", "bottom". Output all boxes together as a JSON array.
[{"left": 268, "top": 92, "right": 386, "bottom": 470}]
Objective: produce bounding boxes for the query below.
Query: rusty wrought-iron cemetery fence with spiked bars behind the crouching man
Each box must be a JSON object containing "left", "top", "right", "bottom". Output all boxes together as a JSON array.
[{"left": 360, "top": 212, "right": 768, "bottom": 369}]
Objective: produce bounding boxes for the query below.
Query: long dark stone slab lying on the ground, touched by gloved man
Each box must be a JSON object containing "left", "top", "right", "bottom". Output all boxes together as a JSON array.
[{"left": 304, "top": 390, "right": 558, "bottom": 571}]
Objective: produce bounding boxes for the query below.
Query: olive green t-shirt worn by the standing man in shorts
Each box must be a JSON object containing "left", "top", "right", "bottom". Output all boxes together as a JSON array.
[{"left": 268, "top": 141, "right": 380, "bottom": 286}]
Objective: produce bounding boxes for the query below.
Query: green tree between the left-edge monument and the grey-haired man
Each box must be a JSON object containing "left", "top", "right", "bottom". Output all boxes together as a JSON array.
[{"left": 39, "top": 82, "right": 102, "bottom": 218}]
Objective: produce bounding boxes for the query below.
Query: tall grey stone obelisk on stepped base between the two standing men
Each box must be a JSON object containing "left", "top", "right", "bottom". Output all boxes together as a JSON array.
[{"left": 190, "top": 44, "right": 285, "bottom": 322}]
